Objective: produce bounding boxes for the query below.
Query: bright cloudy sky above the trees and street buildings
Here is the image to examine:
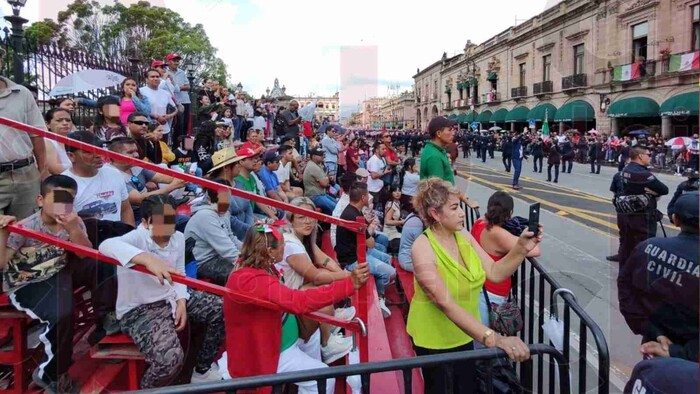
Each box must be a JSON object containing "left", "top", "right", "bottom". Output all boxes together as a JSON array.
[{"left": 0, "top": 0, "right": 559, "bottom": 117}]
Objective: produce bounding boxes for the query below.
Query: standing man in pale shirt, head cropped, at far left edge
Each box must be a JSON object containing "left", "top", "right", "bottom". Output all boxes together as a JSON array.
[{"left": 0, "top": 48, "right": 48, "bottom": 220}]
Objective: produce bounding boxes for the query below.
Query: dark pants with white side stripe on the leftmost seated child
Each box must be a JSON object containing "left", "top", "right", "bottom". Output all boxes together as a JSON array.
[{"left": 11, "top": 258, "right": 117, "bottom": 381}]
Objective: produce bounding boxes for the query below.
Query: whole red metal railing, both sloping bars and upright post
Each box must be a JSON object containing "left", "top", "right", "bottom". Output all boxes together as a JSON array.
[{"left": 0, "top": 117, "right": 369, "bottom": 363}]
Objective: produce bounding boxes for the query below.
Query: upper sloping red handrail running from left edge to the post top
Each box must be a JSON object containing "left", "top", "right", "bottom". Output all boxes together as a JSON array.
[{"left": 0, "top": 116, "right": 365, "bottom": 233}]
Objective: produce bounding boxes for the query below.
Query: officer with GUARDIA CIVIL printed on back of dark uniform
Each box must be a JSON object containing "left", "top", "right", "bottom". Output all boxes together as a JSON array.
[{"left": 617, "top": 192, "right": 700, "bottom": 362}]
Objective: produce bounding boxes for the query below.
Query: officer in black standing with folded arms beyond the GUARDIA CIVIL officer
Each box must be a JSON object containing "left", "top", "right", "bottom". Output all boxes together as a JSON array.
[{"left": 618, "top": 144, "right": 668, "bottom": 265}]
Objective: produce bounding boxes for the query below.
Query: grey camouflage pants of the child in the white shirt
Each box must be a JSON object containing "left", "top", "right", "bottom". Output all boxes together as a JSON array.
[{"left": 120, "top": 290, "right": 225, "bottom": 389}]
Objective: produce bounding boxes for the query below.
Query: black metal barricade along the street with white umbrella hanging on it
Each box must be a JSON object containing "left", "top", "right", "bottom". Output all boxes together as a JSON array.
[{"left": 513, "top": 258, "right": 610, "bottom": 394}]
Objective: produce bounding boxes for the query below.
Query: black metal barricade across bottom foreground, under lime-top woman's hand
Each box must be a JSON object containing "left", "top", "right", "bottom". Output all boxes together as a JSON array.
[{"left": 137, "top": 344, "right": 570, "bottom": 394}]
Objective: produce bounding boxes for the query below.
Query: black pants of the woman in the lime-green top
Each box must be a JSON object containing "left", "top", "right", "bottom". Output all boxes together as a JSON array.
[{"left": 413, "top": 342, "right": 477, "bottom": 394}]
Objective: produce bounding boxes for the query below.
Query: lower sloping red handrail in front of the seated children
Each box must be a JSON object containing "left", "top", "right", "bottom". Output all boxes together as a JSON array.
[{"left": 7, "top": 224, "right": 367, "bottom": 333}]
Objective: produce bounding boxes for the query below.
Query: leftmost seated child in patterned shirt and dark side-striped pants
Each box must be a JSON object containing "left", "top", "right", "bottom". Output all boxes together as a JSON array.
[{"left": 0, "top": 175, "right": 116, "bottom": 393}]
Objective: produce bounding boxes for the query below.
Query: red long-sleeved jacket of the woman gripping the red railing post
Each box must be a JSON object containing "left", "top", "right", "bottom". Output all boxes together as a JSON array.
[{"left": 224, "top": 268, "right": 355, "bottom": 394}]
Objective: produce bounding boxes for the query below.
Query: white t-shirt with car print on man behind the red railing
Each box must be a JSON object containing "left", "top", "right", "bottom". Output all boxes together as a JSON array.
[{"left": 63, "top": 166, "right": 129, "bottom": 222}]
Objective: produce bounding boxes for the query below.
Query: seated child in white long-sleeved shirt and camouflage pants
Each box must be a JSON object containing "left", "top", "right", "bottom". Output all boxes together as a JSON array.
[{"left": 100, "top": 195, "right": 225, "bottom": 389}]
